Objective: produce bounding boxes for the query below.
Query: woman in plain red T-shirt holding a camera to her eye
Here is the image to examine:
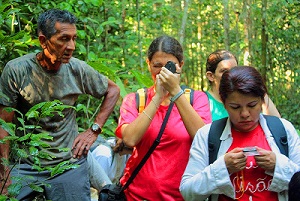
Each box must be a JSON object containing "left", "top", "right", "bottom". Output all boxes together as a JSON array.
[{"left": 116, "top": 36, "right": 211, "bottom": 201}]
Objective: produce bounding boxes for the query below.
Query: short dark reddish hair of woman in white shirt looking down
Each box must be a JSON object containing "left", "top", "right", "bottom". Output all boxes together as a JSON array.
[{"left": 219, "top": 66, "right": 267, "bottom": 103}]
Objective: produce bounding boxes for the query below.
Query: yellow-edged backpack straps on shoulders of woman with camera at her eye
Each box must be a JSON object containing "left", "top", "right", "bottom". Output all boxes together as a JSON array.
[{"left": 135, "top": 86, "right": 194, "bottom": 113}]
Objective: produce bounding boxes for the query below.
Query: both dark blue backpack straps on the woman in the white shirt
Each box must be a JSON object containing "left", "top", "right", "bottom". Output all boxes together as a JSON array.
[{"left": 208, "top": 115, "right": 289, "bottom": 164}]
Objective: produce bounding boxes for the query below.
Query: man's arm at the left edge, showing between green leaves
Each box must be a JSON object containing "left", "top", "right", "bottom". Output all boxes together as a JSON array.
[{"left": 0, "top": 105, "right": 14, "bottom": 194}]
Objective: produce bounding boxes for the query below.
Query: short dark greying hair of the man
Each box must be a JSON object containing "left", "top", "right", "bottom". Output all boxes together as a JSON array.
[{"left": 38, "top": 9, "right": 77, "bottom": 39}]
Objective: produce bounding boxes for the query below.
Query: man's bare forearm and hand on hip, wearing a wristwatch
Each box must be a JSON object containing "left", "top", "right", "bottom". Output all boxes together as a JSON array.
[{"left": 72, "top": 80, "right": 120, "bottom": 158}]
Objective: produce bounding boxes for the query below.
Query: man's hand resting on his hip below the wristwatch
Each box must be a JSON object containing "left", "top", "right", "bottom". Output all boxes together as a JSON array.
[{"left": 72, "top": 129, "right": 98, "bottom": 158}]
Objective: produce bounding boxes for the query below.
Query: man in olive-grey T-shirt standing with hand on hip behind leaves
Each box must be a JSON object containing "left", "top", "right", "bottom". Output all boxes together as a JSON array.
[{"left": 0, "top": 9, "right": 120, "bottom": 201}]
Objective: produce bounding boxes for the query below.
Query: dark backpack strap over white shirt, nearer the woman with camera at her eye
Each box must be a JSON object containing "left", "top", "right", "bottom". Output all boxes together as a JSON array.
[{"left": 208, "top": 117, "right": 228, "bottom": 164}]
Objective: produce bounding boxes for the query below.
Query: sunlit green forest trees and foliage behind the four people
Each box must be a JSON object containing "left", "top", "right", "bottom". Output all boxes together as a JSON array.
[{"left": 0, "top": 0, "right": 300, "bottom": 135}]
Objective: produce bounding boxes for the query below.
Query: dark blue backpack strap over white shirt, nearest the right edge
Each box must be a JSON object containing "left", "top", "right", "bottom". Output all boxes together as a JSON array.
[{"left": 264, "top": 115, "right": 289, "bottom": 157}]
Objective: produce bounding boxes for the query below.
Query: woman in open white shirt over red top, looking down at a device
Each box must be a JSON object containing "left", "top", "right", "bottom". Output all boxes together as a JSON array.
[{"left": 180, "top": 66, "right": 300, "bottom": 201}]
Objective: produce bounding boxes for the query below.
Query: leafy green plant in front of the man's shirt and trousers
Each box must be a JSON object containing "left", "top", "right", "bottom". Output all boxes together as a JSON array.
[{"left": 0, "top": 100, "right": 78, "bottom": 200}]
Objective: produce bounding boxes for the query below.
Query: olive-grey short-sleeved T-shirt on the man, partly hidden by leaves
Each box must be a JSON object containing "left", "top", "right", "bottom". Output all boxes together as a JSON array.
[{"left": 0, "top": 53, "right": 108, "bottom": 166}]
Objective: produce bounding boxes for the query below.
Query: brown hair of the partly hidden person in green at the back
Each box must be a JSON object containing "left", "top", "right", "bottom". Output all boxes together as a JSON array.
[{"left": 206, "top": 50, "right": 238, "bottom": 73}]
